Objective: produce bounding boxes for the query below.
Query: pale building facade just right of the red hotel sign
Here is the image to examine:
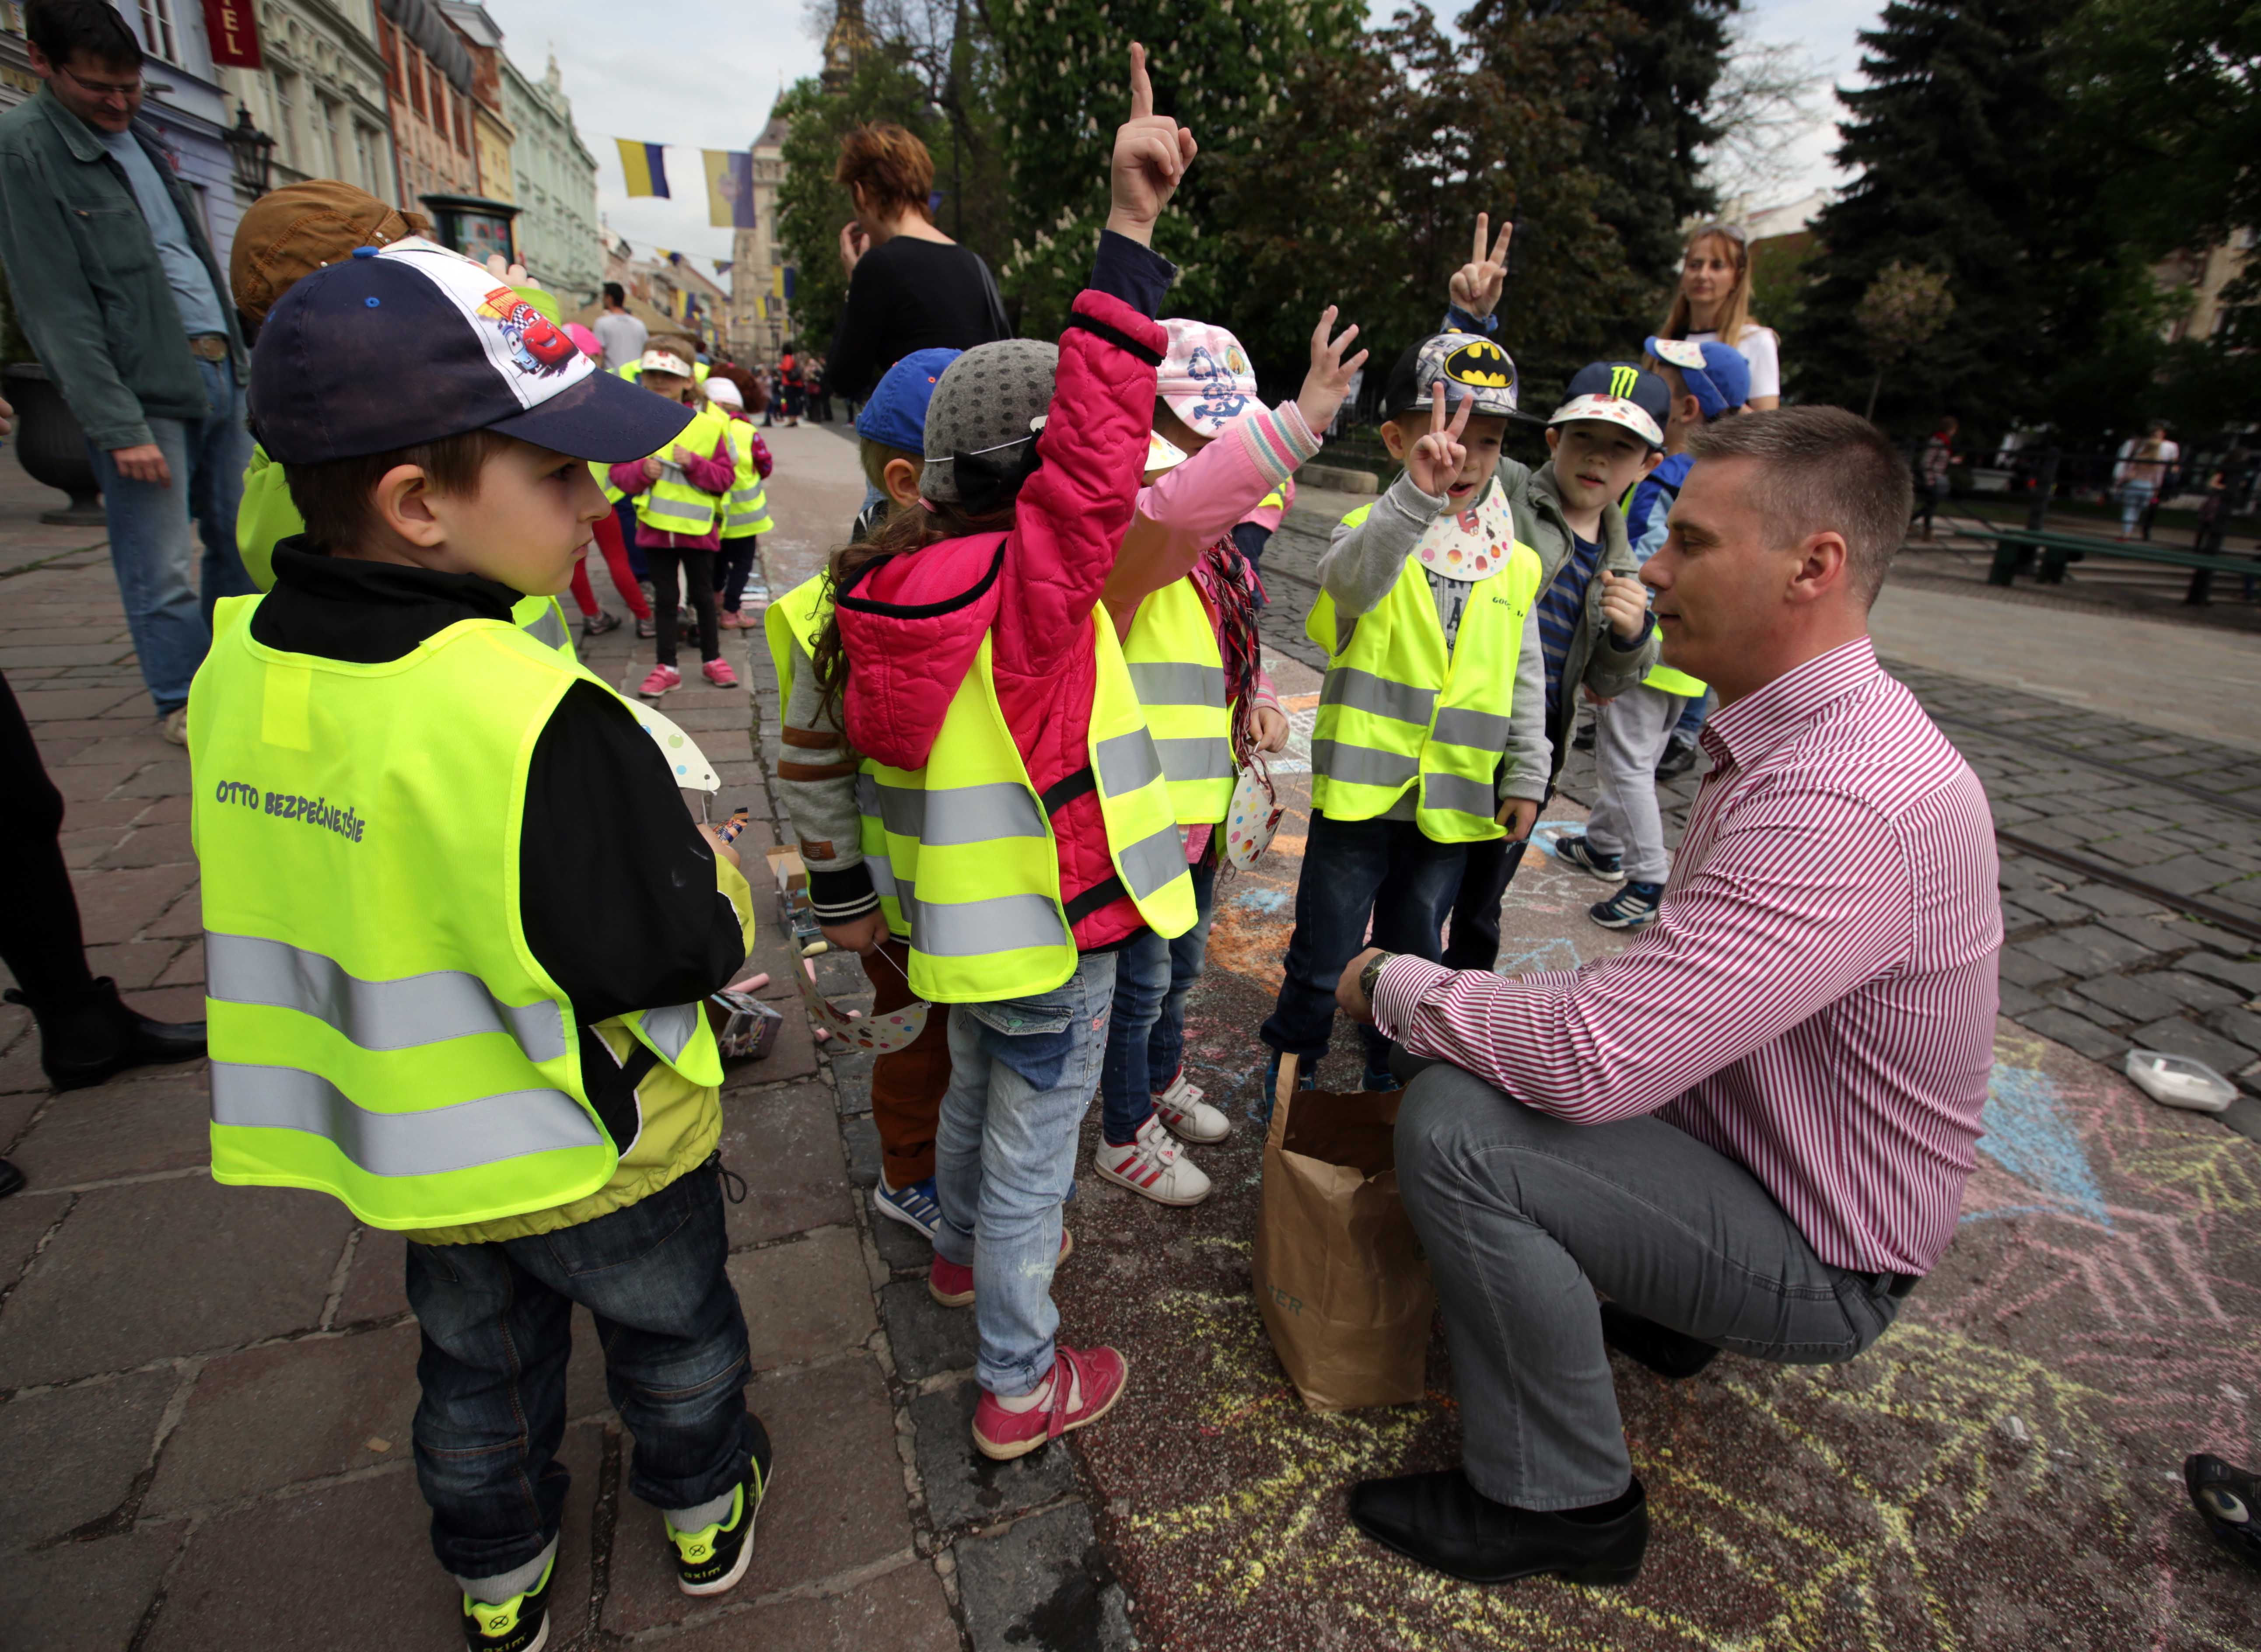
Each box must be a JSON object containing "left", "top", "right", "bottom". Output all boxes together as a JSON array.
[{"left": 219, "top": 0, "right": 400, "bottom": 206}]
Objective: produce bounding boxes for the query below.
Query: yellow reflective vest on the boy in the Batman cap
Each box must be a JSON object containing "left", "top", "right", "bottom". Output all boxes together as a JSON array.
[{"left": 1305, "top": 524, "right": 1540, "bottom": 843}]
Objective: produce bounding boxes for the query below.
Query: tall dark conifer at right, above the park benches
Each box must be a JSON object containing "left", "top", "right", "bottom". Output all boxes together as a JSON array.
[{"left": 1784, "top": 0, "right": 2157, "bottom": 438}]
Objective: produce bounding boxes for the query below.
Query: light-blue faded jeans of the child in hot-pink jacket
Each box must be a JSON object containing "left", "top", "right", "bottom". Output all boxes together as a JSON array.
[{"left": 934, "top": 952, "right": 1117, "bottom": 1399}]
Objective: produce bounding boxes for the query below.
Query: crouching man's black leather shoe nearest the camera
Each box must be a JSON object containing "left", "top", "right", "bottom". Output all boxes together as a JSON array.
[{"left": 1350, "top": 1469, "right": 1648, "bottom": 1584}]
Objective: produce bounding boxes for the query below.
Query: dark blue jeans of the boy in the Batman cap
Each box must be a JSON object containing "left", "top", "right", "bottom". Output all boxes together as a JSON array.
[{"left": 1262, "top": 809, "right": 1467, "bottom": 1071}]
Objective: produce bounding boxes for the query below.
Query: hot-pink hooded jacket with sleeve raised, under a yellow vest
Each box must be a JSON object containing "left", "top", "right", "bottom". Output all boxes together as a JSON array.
[{"left": 836, "top": 291, "right": 1169, "bottom": 952}]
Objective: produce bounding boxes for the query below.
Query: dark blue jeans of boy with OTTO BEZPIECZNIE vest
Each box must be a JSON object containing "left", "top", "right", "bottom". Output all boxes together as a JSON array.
[{"left": 407, "top": 1159, "right": 753, "bottom": 1578}]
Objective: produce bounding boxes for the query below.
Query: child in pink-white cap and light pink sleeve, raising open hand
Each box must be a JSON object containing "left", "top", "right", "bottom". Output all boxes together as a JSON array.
[{"left": 1092, "top": 308, "right": 1365, "bottom": 1204}]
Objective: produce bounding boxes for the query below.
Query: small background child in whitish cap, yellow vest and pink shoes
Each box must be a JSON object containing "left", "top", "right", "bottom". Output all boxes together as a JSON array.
[{"left": 610, "top": 346, "right": 737, "bottom": 700}]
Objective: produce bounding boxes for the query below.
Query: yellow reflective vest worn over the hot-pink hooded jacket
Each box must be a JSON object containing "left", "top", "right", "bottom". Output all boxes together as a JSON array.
[{"left": 857, "top": 617, "right": 1194, "bottom": 1003}]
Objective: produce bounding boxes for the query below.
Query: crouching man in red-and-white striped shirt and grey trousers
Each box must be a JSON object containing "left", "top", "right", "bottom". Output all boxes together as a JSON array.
[{"left": 1338, "top": 407, "right": 2001, "bottom": 1584}]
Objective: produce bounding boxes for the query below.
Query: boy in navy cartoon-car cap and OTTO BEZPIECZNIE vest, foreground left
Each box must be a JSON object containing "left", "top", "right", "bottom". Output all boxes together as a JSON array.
[{"left": 188, "top": 237, "right": 771, "bottom": 1652}]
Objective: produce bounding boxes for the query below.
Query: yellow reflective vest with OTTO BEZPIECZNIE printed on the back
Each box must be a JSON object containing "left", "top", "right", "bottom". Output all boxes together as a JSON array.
[{"left": 188, "top": 597, "right": 721, "bottom": 1229}]
